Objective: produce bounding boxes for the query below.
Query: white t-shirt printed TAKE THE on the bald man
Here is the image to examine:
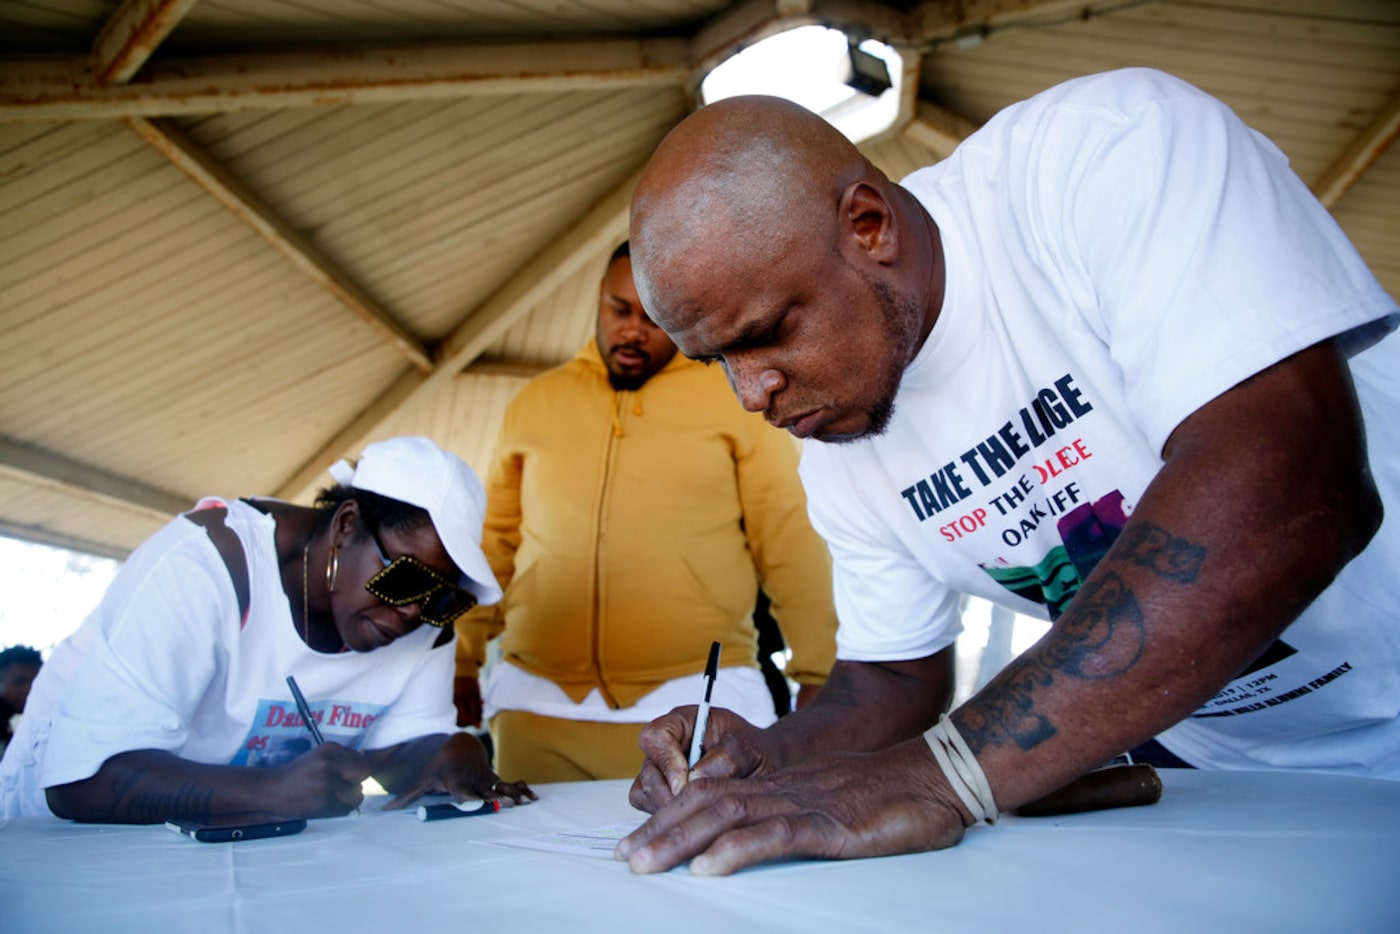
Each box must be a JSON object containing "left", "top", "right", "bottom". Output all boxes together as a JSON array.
[{"left": 802, "top": 69, "right": 1400, "bottom": 779}]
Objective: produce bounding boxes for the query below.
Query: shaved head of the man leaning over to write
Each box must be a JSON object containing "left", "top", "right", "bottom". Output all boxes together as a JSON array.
[{"left": 631, "top": 97, "right": 942, "bottom": 441}]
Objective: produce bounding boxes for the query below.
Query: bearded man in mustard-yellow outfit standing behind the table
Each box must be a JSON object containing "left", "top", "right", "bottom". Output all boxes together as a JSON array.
[{"left": 458, "top": 244, "right": 836, "bottom": 781}]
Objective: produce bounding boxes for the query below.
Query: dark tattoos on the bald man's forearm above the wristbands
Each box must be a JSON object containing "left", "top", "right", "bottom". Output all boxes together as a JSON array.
[{"left": 958, "top": 522, "right": 1205, "bottom": 752}]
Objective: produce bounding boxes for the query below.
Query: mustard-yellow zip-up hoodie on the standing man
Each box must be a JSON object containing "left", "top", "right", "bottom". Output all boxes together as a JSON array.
[{"left": 458, "top": 340, "right": 836, "bottom": 707}]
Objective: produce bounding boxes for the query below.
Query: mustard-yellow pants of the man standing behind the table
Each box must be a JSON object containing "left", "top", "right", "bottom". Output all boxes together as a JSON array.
[{"left": 490, "top": 710, "right": 645, "bottom": 781}]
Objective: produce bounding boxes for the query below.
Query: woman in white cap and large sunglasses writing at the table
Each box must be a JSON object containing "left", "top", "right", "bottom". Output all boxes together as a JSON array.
[{"left": 0, "top": 437, "right": 535, "bottom": 823}]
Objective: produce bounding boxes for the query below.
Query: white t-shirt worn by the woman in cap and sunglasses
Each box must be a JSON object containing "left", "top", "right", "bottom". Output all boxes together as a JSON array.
[{"left": 0, "top": 500, "right": 456, "bottom": 818}]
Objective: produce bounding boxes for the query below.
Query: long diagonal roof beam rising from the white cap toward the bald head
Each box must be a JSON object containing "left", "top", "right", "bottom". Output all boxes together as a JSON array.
[{"left": 276, "top": 168, "right": 641, "bottom": 501}]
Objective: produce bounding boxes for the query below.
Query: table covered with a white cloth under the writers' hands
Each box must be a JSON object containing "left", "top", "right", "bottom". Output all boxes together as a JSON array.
[{"left": 0, "top": 770, "right": 1400, "bottom": 934}]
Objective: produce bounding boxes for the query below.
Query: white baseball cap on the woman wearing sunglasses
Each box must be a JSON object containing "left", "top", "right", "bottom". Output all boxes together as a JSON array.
[{"left": 330, "top": 437, "right": 501, "bottom": 604}]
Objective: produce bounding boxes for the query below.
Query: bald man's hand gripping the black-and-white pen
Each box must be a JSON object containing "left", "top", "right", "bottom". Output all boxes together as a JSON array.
[{"left": 627, "top": 706, "right": 780, "bottom": 814}]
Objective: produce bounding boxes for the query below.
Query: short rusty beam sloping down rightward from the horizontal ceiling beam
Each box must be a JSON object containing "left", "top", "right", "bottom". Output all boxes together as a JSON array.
[{"left": 126, "top": 118, "right": 433, "bottom": 372}]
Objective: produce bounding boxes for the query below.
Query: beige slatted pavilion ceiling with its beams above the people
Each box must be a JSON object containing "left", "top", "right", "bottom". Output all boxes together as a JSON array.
[{"left": 0, "top": 0, "right": 1400, "bottom": 553}]
